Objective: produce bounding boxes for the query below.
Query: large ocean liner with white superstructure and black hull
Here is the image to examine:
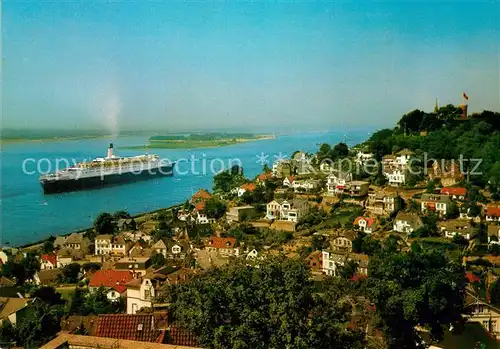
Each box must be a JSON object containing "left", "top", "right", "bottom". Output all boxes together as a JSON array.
[{"left": 40, "top": 143, "right": 175, "bottom": 194}]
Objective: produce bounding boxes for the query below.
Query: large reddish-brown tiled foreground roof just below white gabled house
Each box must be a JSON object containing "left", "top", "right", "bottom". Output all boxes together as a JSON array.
[{"left": 93, "top": 314, "right": 160, "bottom": 342}]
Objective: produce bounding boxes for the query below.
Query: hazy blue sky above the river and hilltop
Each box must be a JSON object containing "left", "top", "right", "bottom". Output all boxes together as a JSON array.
[{"left": 2, "top": 0, "right": 500, "bottom": 131}]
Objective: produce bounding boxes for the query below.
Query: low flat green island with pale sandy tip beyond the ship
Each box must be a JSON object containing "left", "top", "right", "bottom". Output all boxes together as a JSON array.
[{"left": 120, "top": 135, "right": 275, "bottom": 150}]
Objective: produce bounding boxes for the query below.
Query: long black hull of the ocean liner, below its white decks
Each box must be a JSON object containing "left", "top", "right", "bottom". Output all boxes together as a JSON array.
[{"left": 40, "top": 164, "right": 174, "bottom": 194}]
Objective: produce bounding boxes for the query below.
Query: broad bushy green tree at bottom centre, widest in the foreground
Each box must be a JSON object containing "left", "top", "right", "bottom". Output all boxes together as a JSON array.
[{"left": 168, "top": 259, "right": 365, "bottom": 349}]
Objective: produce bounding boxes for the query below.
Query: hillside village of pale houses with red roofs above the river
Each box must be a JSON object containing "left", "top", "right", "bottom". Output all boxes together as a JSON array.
[{"left": 0, "top": 106, "right": 500, "bottom": 348}]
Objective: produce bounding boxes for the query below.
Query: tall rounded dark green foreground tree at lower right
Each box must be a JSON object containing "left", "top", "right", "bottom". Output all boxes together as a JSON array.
[{"left": 367, "top": 250, "right": 466, "bottom": 349}]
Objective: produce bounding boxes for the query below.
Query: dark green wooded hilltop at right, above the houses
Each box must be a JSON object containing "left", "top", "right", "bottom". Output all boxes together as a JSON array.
[{"left": 367, "top": 105, "right": 500, "bottom": 193}]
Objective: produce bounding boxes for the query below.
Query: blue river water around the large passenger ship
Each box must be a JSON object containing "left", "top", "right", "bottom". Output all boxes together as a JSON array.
[{"left": 0, "top": 130, "right": 369, "bottom": 246}]
